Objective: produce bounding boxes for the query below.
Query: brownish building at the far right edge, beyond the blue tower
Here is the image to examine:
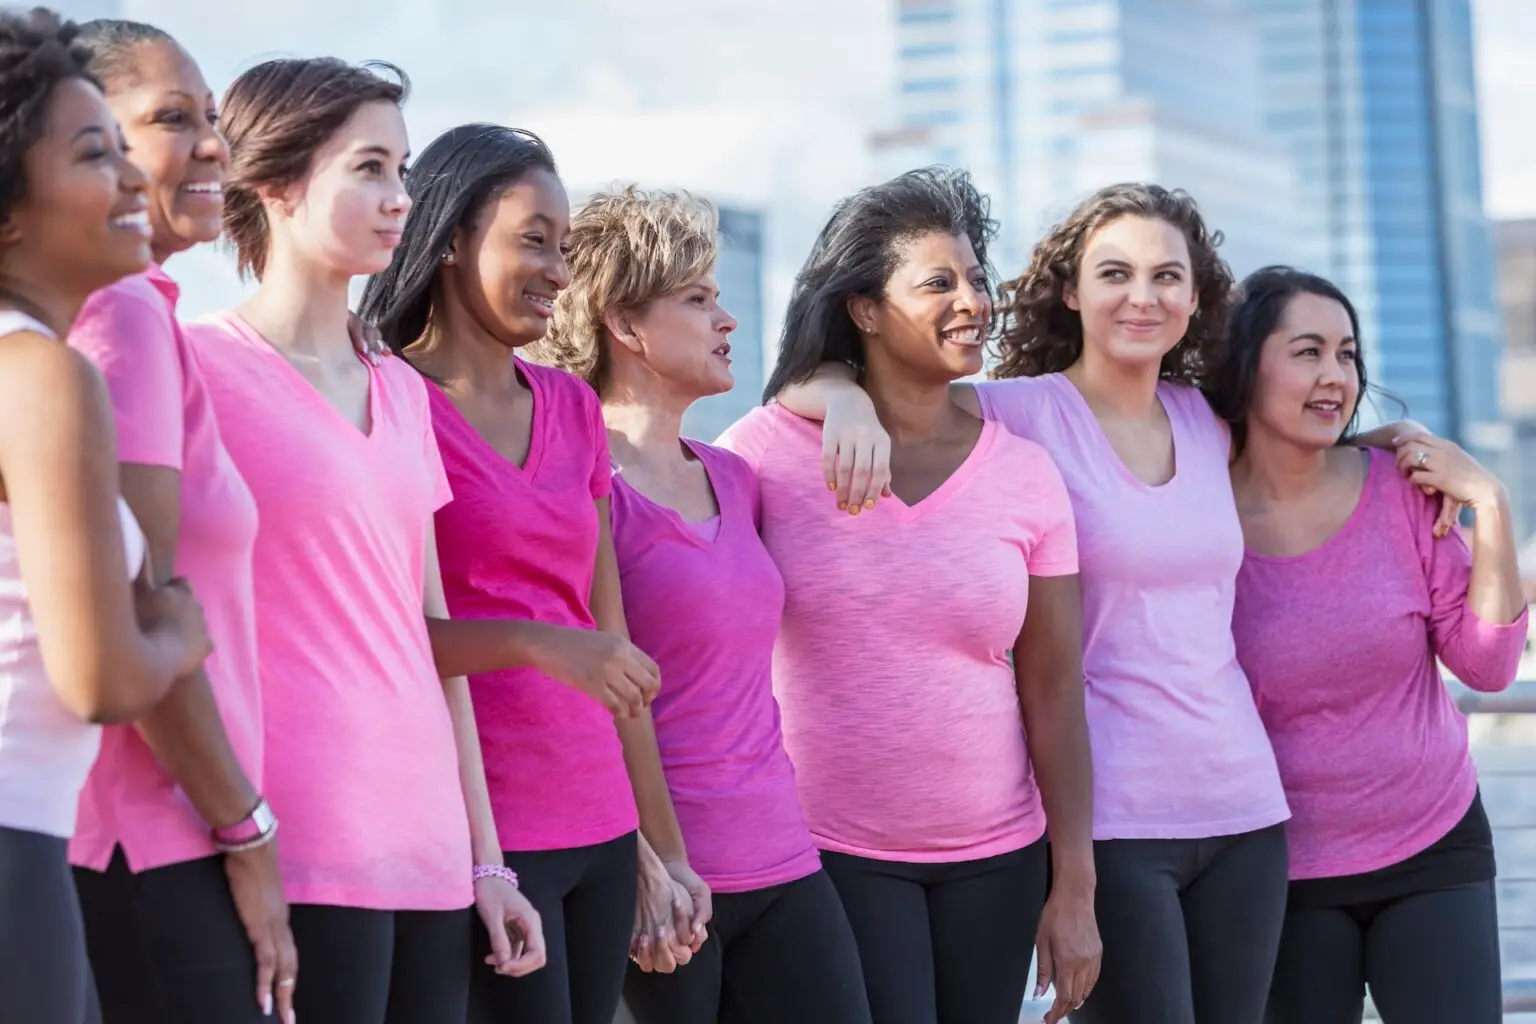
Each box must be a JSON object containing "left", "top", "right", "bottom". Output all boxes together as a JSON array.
[{"left": 1493, "top": 220, "right": 1536, "bottom": 543}]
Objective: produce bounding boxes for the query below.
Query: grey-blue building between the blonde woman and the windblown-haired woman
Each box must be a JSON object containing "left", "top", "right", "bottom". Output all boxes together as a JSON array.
[{"left": 682, "top": 206, "right": 766, "bottom": 442}]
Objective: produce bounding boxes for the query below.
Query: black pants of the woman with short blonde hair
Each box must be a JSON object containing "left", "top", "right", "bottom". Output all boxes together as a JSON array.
[{"left": 624, "top": 870, "right": 869, "bottom": 1024}]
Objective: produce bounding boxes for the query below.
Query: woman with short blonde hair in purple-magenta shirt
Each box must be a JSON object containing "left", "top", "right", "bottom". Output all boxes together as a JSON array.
[{"left": 541, "top": 189, "right": 869, "bottom": 1024}]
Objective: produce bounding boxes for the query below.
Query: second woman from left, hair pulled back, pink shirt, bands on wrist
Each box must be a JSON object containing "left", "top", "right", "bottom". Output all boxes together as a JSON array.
[{"left": 69, "top": 21, "right": 296, "bottom": 1024}]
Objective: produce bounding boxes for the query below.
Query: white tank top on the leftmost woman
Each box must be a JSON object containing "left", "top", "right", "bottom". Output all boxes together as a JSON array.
[{"left": 0, "top": 310, "right": 144, "bottom": 838}]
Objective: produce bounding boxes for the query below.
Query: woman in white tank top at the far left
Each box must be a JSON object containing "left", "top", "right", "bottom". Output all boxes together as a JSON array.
[{"left": 0, "top": 9, "right": 209, "bottom": 1024}]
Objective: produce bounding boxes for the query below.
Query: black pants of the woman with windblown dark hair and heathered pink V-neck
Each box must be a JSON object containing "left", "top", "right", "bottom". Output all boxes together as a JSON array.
[{"left": 822, "top": 840, "right": 1046, "bottom": 1024}]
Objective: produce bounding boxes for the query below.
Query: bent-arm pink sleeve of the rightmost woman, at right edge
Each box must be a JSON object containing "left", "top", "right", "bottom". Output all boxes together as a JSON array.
[{"left": 1395, "top": 477, "right": 1530, "bottom": 692}]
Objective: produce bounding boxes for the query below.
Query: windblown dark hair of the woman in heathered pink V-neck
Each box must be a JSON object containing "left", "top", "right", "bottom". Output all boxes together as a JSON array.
[{"left": 763, "top": 167, "right": 997, "bottom": 402}]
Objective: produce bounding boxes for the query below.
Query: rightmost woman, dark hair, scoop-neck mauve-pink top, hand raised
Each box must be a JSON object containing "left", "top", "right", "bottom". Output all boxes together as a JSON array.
[{"left": 1210, "top": 267, "right": 1528, "bottom": 1024}]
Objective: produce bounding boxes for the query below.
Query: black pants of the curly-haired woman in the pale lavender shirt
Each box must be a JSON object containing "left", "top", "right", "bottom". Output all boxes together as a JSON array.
[{"left": 1072, "top": 824, "right": 1287, "bottom": 1024}]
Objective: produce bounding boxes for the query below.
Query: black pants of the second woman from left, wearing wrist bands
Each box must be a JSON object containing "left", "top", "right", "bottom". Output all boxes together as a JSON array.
[{"left": 75, "top": 847, "right": 270, "bottom": 1024}]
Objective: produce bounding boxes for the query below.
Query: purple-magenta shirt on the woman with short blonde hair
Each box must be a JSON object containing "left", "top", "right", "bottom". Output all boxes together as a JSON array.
[{"left": 613, "top": 442, "right": 820, "bottom": 892}]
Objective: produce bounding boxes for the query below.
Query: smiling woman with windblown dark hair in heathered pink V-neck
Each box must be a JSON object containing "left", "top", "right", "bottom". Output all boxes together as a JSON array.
[{"left": 720, "top": 169, "right": 1100, "bottom": 1024}]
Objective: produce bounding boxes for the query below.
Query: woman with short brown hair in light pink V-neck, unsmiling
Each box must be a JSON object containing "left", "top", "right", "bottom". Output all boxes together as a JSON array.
[{"left": 186, "top": 58, "right": 542, "bottom": 1024}]
